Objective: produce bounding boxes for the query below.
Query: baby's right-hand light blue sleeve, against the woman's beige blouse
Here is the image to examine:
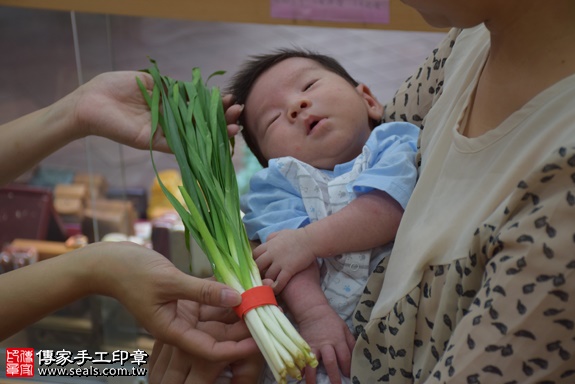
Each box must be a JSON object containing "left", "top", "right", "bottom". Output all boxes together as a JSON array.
[{"left": 350, "top": 122, "right": 420, "bottom": 209}]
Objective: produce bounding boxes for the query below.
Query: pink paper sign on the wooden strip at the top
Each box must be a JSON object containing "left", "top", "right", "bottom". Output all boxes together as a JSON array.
[{"left": 270, "top": 0, "right": 389, "bottom": 24}]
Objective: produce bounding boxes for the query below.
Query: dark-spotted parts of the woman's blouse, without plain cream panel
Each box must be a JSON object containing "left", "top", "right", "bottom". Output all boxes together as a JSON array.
[{"left": 351, "top": 25, "right": 575, "bottom": 384}]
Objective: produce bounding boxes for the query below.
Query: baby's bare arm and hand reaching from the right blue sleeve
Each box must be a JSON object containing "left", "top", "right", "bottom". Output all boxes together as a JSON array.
[{"left": 254, "top": 190, "right": 403, "bottom": 293}]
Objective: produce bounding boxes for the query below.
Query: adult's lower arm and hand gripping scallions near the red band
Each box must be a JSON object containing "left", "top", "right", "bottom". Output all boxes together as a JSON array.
[{"left": 0, "top": 242, "right": 256, "bottom": 360}]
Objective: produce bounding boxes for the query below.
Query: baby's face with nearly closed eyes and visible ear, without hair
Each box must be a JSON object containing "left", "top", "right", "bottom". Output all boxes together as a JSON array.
[{"left": 244, "top": 57, "right": 382, "bottom": 169}]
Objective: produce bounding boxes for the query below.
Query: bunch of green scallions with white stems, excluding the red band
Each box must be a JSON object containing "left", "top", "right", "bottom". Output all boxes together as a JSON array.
[{"left": 137, "top": 60, "right": 318, "bottom": 383}]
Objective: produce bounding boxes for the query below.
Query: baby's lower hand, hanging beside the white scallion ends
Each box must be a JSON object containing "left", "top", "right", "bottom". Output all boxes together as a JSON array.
[{"left": 298, "top": 305, "right": 355, "bottom": 384}]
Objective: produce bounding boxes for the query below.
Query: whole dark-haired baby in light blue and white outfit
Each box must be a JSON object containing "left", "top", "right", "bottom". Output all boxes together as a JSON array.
[{"left": 229, "top": 49, "right": 419, "bottom": 383}]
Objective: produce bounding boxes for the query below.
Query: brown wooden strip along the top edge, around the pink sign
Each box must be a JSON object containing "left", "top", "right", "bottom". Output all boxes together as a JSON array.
[{"left": 0, "top": 0, "right": 441, "bottom": 32}]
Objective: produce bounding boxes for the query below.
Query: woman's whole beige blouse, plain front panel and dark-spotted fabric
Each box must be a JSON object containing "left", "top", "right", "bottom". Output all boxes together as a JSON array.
[{"left": 352, "top": 26, "right": 575, "bottom": 383}]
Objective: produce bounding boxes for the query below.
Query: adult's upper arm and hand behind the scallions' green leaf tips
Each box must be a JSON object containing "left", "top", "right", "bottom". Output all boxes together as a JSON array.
[{"left": 0, "top": 71, "right": 169, "bottom": 185}]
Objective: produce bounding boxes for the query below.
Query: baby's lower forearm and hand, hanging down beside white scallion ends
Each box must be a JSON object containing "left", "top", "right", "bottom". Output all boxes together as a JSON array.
[{"left": 281, "top": 263, "right": 355, "bottom": 384}]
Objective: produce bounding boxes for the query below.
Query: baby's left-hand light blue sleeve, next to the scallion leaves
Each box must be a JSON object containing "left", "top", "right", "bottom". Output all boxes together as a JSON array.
[{"left": 240, "top": 160, "right": 309, "bottom": 242}]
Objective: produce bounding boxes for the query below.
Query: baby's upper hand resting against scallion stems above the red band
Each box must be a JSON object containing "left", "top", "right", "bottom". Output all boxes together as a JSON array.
[{"left": 253, "top": 228, "right": 316, "bottom": 294}]
